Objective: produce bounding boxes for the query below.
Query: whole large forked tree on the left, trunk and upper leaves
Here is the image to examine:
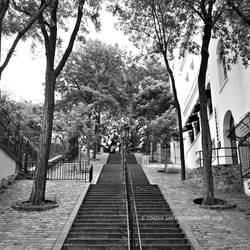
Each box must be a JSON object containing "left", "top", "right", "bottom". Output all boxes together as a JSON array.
[{"left": 12, "top": 0, "right": 99, "bottom": 205}]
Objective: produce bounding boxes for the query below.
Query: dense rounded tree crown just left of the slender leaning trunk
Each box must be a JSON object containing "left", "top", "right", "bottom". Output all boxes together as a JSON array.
[{"left": 133, "top": 77, "right": 175, "bottom": 151}]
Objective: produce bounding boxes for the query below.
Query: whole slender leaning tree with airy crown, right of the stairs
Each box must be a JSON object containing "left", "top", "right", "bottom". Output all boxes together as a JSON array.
[{"left": 110, "top": 0, "right": 188, "bottom": 180}]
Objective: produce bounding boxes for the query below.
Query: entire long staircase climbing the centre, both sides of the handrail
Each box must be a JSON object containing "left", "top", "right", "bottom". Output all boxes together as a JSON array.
[{"left": 62, "top": 154, "right": 191, "bottom": 250}]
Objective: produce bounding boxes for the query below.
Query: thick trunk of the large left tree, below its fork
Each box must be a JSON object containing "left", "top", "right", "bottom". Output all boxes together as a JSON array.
[{"left": 29, "top": 69, "right": 56, "bottom": 205}]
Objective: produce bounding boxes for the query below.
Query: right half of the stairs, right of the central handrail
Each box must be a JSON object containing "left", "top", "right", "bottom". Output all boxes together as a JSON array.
[{"left": 127, "top": 155, "right": 191, "bottom": 250}]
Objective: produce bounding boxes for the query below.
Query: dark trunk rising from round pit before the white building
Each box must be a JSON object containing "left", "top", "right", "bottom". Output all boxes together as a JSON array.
[{"left": 198, "top": 24, "right": 214, "bottom": 205}]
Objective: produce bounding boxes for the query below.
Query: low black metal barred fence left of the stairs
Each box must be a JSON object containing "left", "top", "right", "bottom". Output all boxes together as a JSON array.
[{"left": 47, "top": 161, "right": 93, "bottom": 182}]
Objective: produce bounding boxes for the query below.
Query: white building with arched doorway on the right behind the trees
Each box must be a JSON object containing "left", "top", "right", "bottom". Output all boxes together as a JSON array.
[{"left": 175, "top": 37, "right": 250, "bottom": 191}]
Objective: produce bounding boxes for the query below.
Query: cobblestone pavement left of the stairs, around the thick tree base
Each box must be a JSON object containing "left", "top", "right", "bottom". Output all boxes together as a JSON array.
[{"left": 0, "top": 154, "right": 107, "bottom": 250}]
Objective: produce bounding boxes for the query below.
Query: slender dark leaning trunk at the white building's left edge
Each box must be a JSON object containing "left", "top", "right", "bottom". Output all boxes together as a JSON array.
[{"left": 163, "top": 53, "right": 186, "bottom": 181}]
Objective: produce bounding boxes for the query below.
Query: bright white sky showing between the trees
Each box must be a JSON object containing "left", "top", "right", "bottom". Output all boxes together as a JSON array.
[{"left": 0, "top": 9, "right": 135, "bottom": 103}]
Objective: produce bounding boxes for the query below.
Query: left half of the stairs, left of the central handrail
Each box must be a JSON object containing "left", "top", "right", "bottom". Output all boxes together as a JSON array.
[{"left": 62, "top": 154, "right": 128, "bottom": 250}]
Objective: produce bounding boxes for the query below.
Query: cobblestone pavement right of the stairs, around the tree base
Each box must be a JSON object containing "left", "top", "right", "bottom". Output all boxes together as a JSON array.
[{"left": 143, "top": 164, "right": 250, "bottom": 250}]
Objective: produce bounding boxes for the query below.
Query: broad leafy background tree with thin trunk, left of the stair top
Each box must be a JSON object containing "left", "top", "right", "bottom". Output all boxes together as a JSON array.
[{"left": 57, "top": 40, "right": 128, "bottom": 159}]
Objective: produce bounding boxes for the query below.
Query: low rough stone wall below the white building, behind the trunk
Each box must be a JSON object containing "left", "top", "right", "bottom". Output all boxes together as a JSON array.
[{"left": 187, "top": 165, "right": 242, "bottom": 192}]
